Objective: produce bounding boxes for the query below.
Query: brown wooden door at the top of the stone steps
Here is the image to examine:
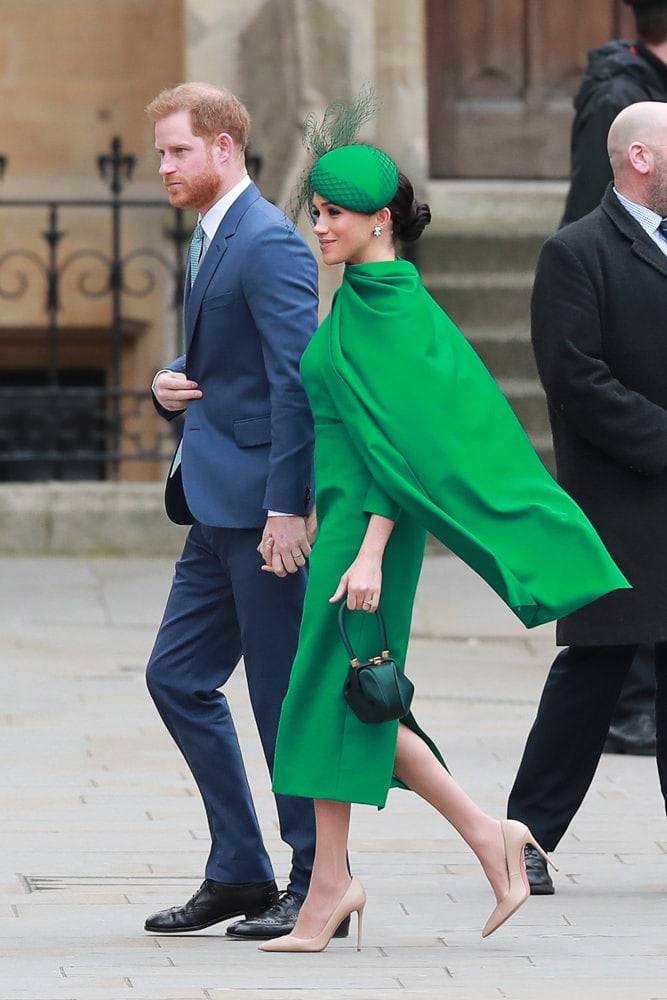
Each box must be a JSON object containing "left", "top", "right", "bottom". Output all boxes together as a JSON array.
[{"left": 426, "top": 0, "right": 634, "bottom": 178}]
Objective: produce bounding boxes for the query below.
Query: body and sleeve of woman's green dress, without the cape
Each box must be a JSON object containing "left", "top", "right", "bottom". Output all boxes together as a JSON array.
[{"left": 274, "top": 308, "right": 434, "bottom": 806}]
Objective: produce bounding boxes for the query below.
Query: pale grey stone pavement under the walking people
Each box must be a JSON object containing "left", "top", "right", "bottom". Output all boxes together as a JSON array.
[{"left": 0, "top": 554, "right": 667, "bottom": 1000}]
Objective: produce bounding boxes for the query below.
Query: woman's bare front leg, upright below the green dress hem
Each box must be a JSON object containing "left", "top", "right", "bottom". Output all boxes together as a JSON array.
[{"left": 292, "top": 799, "right": 351, "bottom": 938}]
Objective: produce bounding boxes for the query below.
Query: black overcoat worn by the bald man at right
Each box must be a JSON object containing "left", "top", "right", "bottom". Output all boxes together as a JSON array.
[{"left": 531, "top": 185, "right": 667, "bottom": 645}]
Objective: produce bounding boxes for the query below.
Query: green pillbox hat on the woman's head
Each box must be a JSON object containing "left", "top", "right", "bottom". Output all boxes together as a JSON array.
[{"left": 310, "top": 145, "right": 398, "bottom": 214}]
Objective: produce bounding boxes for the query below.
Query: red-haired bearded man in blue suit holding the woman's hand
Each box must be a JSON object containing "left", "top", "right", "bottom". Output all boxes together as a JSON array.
[{"left": 145, "top": 83, "right": 324, "bottom": 939}]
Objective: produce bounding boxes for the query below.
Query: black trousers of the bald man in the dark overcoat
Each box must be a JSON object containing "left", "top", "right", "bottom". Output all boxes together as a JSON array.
[{"left": 507, "top": 643, "right": 667, "bottom": 851}]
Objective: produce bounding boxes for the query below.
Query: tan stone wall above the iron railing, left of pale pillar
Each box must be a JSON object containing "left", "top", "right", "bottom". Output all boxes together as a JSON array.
[{"left": 0, "top": 0, "right": 185, "bottom": 197}]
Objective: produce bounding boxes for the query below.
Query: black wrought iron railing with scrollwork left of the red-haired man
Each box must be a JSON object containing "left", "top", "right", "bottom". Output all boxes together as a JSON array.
[{"left": 0, "top": 137, "right": 190, "bottom": 481}]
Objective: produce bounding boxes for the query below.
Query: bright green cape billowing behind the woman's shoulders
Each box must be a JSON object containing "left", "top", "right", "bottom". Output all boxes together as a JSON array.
[{"left": 325, "top": 260, "right": 629, "bottom": 627}]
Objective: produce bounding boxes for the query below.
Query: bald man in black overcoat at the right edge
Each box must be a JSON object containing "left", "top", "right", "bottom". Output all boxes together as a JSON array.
[{"left": 508, "top": 102, "right": 667, "bottom": 882}]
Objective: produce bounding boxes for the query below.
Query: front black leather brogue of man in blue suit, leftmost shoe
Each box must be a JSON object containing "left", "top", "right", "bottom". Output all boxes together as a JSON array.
[{"left": 144, "top": 878, "right": 278, "bottom": 934}]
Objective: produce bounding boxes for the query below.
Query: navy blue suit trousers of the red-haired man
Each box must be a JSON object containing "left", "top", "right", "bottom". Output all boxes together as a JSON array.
[{"left": 147, "top": 523, "right": 315, "bottom": 894}]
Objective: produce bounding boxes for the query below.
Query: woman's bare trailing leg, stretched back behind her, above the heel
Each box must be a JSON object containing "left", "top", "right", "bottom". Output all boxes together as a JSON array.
[{"left": 394, "top": 725, "right": 509, "bottom": 902}]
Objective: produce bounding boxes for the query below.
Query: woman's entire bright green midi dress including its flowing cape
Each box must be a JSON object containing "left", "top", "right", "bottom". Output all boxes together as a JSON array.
[{"left": 273, "top": 260, "right": 628, "bottom": 806}]
